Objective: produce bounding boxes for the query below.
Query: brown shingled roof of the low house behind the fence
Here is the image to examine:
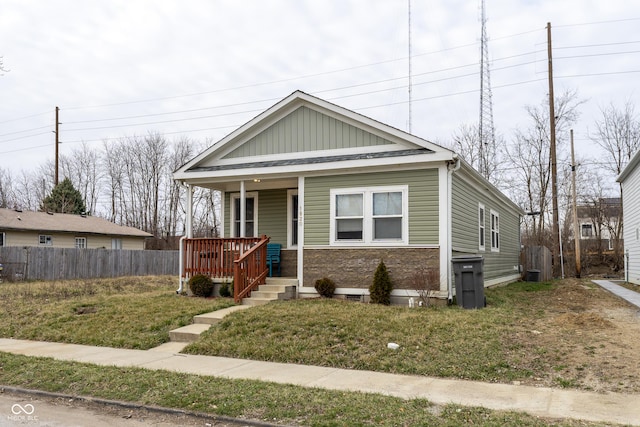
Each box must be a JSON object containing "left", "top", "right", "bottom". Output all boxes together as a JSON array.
[{"left": 0, "top": 209, "right": 153, "bottom": 237}]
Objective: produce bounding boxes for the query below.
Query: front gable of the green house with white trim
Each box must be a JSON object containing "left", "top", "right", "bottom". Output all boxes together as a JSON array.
[{"left": 174, "top": 91, "right": 454, "bottom": 181}]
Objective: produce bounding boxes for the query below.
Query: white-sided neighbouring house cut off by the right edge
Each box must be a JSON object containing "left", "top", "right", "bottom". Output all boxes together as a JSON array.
[{"left": 617, "top": 151, "right": 640, "bottom": 285}]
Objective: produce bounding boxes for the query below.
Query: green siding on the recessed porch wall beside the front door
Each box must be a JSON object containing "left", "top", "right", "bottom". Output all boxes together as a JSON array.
[{"left": 224, "top": 188, "right": 287, "bottom": 247}]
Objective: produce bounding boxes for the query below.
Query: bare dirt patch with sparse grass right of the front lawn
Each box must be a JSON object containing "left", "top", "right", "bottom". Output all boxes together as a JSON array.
[{"left": 506, "top": 279, "right": 640, "bottom": 393}]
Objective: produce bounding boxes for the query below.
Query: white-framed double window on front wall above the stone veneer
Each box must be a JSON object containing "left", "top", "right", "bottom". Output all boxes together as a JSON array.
[{"left": 330, "top": 186, "right": 409, "bottom": 244}]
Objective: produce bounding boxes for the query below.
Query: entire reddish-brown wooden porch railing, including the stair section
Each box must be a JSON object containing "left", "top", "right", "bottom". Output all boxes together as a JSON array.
[{"left": 181, "top": 236, "right": 269, "bottom": 303}]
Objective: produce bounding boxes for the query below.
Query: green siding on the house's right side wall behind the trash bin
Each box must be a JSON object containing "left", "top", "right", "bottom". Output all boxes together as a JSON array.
[{"left": 451, "top": 173, "right": 520, "bottom": 280}]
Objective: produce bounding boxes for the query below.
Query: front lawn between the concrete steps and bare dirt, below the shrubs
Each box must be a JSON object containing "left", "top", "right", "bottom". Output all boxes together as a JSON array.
[{"left": 185, "top": 299, "right": 531, "bottom": 381}]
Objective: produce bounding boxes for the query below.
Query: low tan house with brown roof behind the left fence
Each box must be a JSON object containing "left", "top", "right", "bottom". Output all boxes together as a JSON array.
[{"left": 0, "top": 209, "right": 153, "bottom": 249}]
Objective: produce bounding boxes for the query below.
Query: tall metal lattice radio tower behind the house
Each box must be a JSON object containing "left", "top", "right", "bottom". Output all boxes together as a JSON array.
[{"left": 478, "top": 0, "right": 496, "bottom": 179}]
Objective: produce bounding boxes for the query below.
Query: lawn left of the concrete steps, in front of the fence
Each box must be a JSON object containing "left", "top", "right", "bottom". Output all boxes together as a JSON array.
[{"left": 0, "top": 277, "right": 233, "bottom": 350}]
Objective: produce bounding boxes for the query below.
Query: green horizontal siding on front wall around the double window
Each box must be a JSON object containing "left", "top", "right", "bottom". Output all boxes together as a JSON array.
[{"left": 304, "top": 168, "right": 439, "bottom": 246}]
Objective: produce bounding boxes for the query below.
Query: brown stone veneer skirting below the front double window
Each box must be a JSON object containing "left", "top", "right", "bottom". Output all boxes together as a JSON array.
[{"left": 304, "top": 248, "right": 440, "bottom": 290}]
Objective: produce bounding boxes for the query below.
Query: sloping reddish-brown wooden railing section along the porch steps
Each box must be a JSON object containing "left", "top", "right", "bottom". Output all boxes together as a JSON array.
[{"left": 233, "top": 236, "right": 269, "bottom": 303}]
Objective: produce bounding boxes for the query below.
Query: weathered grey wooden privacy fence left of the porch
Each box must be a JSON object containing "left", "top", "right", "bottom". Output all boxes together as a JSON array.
[{"left": 0, "top": 246, "right": 179, "bottom": 280}]
